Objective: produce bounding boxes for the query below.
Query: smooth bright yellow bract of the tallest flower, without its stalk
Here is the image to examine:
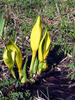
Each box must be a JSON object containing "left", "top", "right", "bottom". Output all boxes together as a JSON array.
[{"left": 30, "top": 16, "right": 42, "bottom": 51}]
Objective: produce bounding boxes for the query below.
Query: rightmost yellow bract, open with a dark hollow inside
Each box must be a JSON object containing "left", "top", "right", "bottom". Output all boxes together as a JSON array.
[{"left": 38, "top": 30, "right": 51, "bottom": 62}]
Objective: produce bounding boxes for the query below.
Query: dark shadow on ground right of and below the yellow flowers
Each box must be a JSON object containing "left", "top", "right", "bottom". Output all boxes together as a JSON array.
[{"left": 27, "top": 46, "right": 75, "bottom": 100}]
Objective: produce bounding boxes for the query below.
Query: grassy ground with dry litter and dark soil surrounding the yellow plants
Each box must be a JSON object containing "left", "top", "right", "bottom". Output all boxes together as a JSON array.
[{"left": 0, "top": 0, "right": 75, "bottom": 100}]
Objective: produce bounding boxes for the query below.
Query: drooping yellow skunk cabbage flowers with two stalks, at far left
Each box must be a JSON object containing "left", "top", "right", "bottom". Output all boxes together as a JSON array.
[{"left": 3, "top": 38, "right": 22, "bottom": 78}]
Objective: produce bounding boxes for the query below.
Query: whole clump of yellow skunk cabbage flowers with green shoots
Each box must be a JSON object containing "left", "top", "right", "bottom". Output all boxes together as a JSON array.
[{"left": 1, "top": 16, "right": 51, "bottom": 83}]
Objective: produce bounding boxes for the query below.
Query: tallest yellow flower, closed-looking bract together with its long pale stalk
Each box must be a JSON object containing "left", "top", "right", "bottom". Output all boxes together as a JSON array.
[{"left": 30, "top": 16, "right": 42, "bottom": 72}]
